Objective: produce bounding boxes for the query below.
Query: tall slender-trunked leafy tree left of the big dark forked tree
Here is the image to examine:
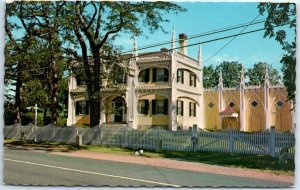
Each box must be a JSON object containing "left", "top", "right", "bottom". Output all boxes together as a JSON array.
[{"left": 7, "top": 2, "right": 68, "bottom": 124}]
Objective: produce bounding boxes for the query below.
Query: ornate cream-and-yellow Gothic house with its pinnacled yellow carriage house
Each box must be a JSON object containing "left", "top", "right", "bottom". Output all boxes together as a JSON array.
[{"left": 67, "top": 31, "right": 293, "bottom": 131}]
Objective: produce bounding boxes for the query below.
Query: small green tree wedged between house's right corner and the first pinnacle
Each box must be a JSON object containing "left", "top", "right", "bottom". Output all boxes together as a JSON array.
[{"left": 203, "top": 65, "right": 218, "bottom": 88}]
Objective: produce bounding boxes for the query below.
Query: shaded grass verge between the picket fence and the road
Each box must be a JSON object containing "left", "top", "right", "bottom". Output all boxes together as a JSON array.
[{"left": 4, "top": 140, "right": 295, "bottom": 175}]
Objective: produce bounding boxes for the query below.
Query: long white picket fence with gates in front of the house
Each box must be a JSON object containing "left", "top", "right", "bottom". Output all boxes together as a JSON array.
[{"left": 4, "top": 124, "right": 295, "bottom": 157}]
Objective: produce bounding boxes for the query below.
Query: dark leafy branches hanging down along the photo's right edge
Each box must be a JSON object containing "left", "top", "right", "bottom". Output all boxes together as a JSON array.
[{"left": 258, "top": 3, "right": 296, "bottom": 101}]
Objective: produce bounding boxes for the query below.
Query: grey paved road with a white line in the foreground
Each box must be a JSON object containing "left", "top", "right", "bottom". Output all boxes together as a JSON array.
[{"left": 4, "top": 148, "right": 292, "bottom": 187}]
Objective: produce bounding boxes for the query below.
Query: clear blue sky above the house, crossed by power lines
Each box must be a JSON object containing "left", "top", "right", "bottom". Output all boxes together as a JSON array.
[{"left": 113, "top": 2, "right": 292, "bottom": 71}]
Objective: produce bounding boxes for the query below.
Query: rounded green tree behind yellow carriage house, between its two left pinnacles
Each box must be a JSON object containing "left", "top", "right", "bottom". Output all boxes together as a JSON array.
[{"left": 216, "top": 61, "right": 242, "bottom": 88}]
